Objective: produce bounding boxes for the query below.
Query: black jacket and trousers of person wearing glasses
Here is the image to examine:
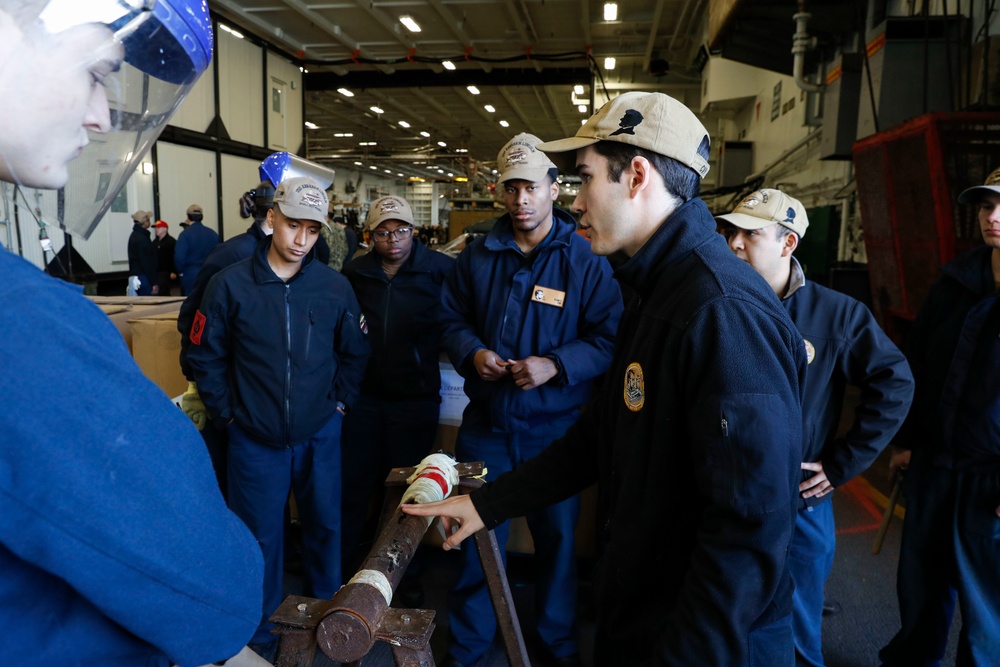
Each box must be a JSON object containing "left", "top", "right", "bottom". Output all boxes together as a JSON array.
[{"left": 341, "top": 243, "right": 455, "bottom": 574}]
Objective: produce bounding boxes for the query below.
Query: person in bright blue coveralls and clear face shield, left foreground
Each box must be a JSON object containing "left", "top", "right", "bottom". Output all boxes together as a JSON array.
[{"left": 0, "top": 0, "right": 262, "bottom": 667}]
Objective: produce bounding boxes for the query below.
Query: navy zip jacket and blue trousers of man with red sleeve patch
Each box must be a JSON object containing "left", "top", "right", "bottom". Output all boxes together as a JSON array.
[{"left": 188, "top": 238, "right": 369, "bottom": 643}]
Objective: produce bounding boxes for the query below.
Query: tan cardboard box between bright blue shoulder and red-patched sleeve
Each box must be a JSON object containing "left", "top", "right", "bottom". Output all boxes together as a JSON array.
[{"left": 128, "top": 312, "right": 187, "bottom": 398}]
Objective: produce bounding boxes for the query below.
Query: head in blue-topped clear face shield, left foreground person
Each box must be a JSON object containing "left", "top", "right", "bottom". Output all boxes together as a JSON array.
[{"left": 0, "top": 0, "right": 212, "bottom": 239}]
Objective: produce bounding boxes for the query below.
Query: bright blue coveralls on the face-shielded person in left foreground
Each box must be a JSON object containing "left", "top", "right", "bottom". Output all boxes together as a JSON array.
[{"left": 0, "top": 247, "right": 263, "bottom": 667}]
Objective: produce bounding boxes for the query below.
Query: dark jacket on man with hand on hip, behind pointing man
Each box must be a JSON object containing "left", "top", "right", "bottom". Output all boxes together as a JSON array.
[{"left": 781, "top": 258, "right": 913, "bottom": 507}]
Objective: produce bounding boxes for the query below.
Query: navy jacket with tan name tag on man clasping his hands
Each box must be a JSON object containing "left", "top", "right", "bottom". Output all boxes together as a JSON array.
[{"left": 443, "top": 209, "right": 622, "bottom": 432}]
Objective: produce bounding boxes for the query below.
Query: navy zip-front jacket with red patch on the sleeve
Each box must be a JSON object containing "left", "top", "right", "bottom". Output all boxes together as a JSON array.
[{"left": 188, "top": 238, "right": 369, "bottom": 447}]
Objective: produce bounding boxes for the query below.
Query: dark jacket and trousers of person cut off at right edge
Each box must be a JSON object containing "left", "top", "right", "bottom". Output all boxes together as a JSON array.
[{"left": 879, "top": 247, "right": 1000, "bottom": 667}]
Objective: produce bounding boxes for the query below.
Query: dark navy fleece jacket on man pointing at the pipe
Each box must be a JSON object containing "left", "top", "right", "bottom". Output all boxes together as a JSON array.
[{"left": 472, "top": 199, "right": 806, "bottom": 666}]
